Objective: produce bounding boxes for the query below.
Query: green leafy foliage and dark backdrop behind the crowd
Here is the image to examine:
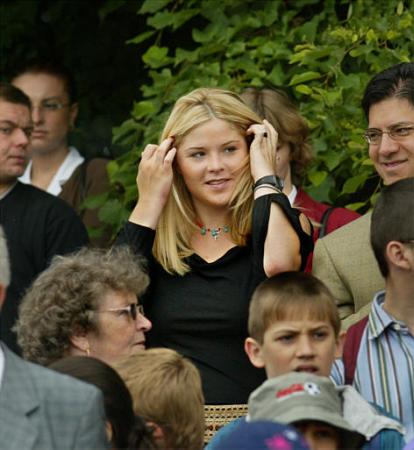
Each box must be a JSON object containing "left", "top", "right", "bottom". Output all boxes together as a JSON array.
[{"left": 0, "top": 0, "right": 414, "bottom": 234}]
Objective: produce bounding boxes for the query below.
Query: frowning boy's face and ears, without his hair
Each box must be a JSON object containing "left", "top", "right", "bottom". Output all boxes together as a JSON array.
[{"left": 245, "top": 319, "right": 344, "bottom": 378}]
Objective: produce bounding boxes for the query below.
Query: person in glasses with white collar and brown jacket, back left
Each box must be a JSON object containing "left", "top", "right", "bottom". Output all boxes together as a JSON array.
[{"left": 12, "top": 60, "right": 110, "bottom": 246}]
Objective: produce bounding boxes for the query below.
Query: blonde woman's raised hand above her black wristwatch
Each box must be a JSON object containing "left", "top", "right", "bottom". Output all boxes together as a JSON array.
[{"left": 246, "top": 119, "right": 278, "bottom": 182}]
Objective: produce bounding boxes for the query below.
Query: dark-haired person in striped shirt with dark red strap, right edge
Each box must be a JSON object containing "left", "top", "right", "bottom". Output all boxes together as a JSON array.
[{"left": 336, "top": 177, "right": 414, "bottom": 440}]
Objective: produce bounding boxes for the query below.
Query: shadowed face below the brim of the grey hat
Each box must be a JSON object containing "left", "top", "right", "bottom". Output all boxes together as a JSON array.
[{"left": 293, "top": 421, "right": 340, "bottom": 450}]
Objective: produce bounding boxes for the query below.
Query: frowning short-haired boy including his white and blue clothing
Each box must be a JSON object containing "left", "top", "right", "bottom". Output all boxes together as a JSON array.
[{"left": 207, "top": 272, "right": 403, "bottom": 450}]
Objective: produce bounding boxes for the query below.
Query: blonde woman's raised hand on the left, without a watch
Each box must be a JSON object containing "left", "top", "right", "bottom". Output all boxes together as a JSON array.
[{"left": 129, "top": 137, "right": 177, "bottom": 229}]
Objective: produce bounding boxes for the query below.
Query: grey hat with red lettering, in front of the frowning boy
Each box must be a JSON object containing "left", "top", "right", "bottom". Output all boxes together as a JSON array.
[{"left": 248, "top": 372, "right": 365, "bottom": 448}]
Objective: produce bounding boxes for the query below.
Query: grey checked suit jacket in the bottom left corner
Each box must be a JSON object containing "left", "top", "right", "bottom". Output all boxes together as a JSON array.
[{"left": 0, "top": 345, "right": 109, "bottom": 450}]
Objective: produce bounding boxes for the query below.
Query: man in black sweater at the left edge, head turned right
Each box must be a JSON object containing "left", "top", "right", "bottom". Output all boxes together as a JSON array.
[{"left": 0, "top": 84, "right": 88, "bottom": 352}]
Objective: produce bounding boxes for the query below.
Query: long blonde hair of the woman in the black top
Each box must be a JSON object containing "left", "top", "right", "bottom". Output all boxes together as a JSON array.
[{"left": 153, "top": 88, "right": 266, "bottom": 275}]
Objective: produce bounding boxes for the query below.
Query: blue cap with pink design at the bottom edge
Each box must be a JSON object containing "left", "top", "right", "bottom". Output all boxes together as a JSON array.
[{"left": 214, "top": 420, "right": 309, "bottom": 450}]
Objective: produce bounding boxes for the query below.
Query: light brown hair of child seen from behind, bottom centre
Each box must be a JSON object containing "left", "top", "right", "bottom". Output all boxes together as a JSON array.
[{"left": 114, "top": 348, "right": 205, "bottom": 450}]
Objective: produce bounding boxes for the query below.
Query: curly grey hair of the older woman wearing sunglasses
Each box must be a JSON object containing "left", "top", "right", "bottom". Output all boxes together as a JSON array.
[{"left": 15, "top": 246, "right": 149, "bottom": 365}]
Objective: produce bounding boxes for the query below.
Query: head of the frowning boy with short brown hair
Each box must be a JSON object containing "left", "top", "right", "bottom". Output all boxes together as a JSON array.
[{"left": 245, "top": 272, "right": 344, "bottom": 378}]
